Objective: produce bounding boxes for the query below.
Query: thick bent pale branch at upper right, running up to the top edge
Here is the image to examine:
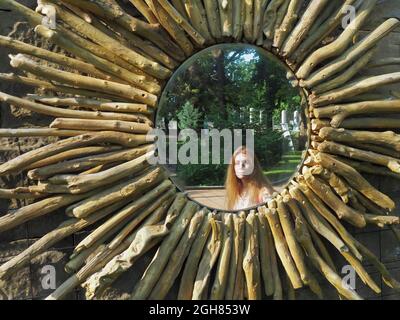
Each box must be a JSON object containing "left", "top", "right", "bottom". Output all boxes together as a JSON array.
[{"left": 296, "top": 0, "right": 377, "bottom": 79}]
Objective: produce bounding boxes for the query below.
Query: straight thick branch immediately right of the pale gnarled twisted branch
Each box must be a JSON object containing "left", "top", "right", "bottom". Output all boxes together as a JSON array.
[{"left": 131, "top": 202, "right": 199, "bottom": 300}]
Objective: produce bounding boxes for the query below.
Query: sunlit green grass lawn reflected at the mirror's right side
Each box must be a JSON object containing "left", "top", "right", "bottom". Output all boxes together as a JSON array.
[{"left": 263, "top": 151, "right": 302, "bottom": 183}]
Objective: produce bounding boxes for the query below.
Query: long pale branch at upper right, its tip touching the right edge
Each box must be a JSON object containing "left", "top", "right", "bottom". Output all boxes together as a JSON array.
[{"left": 302, "top": 18, "right": 400, "bottom": 88}]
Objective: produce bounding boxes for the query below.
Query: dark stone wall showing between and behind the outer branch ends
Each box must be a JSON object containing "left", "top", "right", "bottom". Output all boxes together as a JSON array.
[{"left": 0, "top": 0, "right": 400, "bottom": 299}]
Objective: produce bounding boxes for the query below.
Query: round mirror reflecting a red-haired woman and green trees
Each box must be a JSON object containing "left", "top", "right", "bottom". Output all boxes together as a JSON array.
[{"left": 156, "top": 44, "right": 309, "bottom": 211}]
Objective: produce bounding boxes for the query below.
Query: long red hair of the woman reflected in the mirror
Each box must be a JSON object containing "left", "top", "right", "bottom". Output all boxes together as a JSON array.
[{"left": 225, "top": 146, "right": 275, "bottom": 210}]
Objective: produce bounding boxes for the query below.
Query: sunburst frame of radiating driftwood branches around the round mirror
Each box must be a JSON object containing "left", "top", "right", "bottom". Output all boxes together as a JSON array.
[{"left": 0, "top": 0, "right": 400, "bottom": 299}]
